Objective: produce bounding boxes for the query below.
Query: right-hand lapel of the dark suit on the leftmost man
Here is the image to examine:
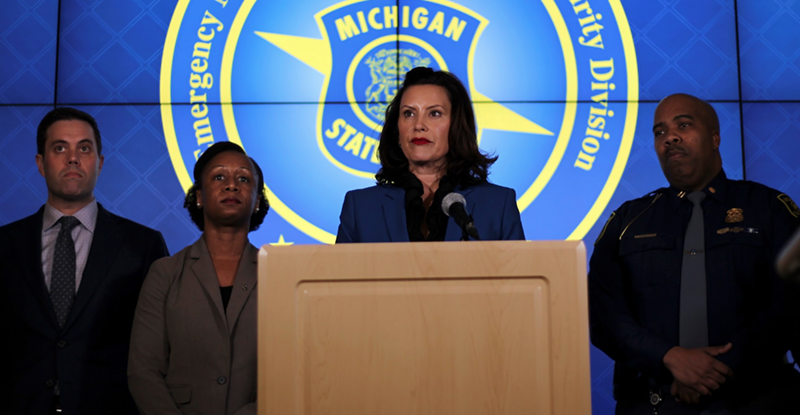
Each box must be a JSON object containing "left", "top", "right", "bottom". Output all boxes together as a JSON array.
[{"left": 64, "top": 203, "right": 123, "bottom": 331}]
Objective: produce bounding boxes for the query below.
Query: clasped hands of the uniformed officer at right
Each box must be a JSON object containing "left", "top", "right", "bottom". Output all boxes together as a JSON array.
[{"left": 663, "top": 343, "right": 733, "bottom": 395}]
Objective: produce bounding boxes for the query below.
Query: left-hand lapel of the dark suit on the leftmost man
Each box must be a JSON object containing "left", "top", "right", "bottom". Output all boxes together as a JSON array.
[{"left": 16, "top": 206, "right": 58, "bottom": 329}]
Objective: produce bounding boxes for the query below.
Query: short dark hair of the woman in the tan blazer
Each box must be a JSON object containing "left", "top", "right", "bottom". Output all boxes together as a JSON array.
[{"left": 183, "top": 141, "right": 269, "bottom": 232}]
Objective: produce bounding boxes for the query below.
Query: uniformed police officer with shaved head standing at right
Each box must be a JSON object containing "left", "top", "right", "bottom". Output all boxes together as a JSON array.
[{"left": 589, "top": 94, "right": 800, "bottom": 414}]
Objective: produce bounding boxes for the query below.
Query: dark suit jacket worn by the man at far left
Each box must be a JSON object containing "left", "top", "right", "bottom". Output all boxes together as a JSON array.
[{"left": 0, "top": 204, "right": 168, "bottom": 415}]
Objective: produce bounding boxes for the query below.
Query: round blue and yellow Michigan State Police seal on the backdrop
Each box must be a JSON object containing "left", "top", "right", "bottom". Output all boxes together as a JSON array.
[{"left": 161, "top": 0, "right": 638, "bottom": 244}]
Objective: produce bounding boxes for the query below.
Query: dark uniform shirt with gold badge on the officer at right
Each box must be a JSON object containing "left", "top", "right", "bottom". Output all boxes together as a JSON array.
[{"left": 589, "top": 172, "right": 800, "bottom": 399}]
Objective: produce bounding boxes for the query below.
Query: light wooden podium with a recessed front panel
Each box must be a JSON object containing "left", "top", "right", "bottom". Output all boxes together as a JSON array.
[{"left": 258, "top": 241, "right": 591, "bottom": 415}]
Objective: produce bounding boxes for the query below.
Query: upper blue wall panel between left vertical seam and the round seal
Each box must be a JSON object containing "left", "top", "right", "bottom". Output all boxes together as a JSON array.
[{"left": 58, "top": 0, "right": 175, "bottom": 104}]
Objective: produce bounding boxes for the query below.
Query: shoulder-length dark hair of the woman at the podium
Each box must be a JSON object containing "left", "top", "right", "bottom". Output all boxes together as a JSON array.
[{"left": 375, "top": 67, "right": 497, "bottom": 186}]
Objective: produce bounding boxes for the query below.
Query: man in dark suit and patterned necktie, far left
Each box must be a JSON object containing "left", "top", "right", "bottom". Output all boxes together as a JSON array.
[{"left": 0, "top": 108, "right": 168, "bottom": 415}]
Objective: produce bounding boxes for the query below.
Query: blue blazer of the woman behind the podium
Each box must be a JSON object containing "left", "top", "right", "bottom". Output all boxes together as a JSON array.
[{"left": 336, "top": 183, "right": 525, "bottom": 243}]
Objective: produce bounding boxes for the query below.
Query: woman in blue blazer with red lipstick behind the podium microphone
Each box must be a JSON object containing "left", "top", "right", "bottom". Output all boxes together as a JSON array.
[{"left": 336, "top": 67, "right": 525, "bottom": 243}]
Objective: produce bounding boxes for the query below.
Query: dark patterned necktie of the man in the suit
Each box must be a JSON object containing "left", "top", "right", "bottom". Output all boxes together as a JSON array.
[{"left": 50, "top": 216, "right": 81, "bottom": 327}]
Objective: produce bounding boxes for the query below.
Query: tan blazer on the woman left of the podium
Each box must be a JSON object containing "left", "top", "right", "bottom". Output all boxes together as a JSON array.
[{"left": 128, "top": 238, "right": 258, "bottom": 415}]
